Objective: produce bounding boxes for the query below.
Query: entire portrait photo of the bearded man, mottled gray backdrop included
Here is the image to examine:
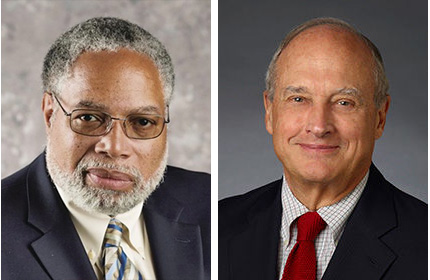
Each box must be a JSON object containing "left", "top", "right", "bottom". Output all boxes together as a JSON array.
[{"left": 1, "top": 0, "right": 211, "bottom": 280}]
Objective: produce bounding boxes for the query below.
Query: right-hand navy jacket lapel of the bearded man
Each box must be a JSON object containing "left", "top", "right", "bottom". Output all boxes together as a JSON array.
[{"left": 143, "top": 186, "right": 204, "bottom": 280}]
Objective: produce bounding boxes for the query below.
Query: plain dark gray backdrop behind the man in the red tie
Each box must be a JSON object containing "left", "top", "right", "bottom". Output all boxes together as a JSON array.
[{"left": 218, "top": 0, "right": 427, "bottom": 201}]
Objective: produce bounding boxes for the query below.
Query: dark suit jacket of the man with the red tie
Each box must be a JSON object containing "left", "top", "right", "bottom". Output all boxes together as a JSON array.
[{"left": 218, "top": 165, "right": 427, "bottom": 280}]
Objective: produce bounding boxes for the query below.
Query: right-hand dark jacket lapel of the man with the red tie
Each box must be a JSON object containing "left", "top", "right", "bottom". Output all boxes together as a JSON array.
[{"left": 322, "top": 165, "right": 397, "bottom": 280}]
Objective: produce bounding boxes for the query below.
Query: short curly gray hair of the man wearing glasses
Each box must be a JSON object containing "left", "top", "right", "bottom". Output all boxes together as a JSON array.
[{"left": 42, "top": 17, "right": 175, "bottom": 105}]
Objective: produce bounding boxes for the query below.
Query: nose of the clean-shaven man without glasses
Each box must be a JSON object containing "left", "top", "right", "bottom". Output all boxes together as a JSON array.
[{"left": 306, "top": 104, "right": 334, "bottom": 138}]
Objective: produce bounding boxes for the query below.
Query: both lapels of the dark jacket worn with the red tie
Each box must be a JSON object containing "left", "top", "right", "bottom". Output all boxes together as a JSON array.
[{"left": 229, "top": 164, "right": 397, "bottom": 280}]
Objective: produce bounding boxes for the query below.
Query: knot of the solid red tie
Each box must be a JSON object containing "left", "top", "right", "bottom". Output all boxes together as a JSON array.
[{"left": 297, "top": 212, "right": 326, "bottom": 242}]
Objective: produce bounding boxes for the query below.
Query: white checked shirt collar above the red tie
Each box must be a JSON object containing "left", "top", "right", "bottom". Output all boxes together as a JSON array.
[{"left": 281, "top": 171, "right": 369, "bottom": 244}]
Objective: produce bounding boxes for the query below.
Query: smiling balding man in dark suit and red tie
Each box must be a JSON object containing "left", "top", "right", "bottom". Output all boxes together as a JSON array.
[{"left": 219, "top": 18, "right": 427, "bottom": 280}]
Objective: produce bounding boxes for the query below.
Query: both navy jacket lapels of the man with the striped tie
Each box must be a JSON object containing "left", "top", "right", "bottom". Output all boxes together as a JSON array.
[{"left": 27, "top": 154, "right": 208, "bottom": 280}]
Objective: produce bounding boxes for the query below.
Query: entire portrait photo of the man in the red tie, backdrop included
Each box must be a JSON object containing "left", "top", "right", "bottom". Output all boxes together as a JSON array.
[{"left": 218, "top": 1, "right": 428, "bottom": 280}]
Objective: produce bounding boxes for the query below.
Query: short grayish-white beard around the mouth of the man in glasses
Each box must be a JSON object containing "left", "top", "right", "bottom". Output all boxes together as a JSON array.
[{"left": 46, "top": 141, "right": 168, "bottom": 215}]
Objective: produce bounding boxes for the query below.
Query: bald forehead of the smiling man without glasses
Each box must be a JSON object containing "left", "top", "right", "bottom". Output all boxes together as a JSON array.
[{"left": 275, "top": 23, "right": 376, "bottom": 100}]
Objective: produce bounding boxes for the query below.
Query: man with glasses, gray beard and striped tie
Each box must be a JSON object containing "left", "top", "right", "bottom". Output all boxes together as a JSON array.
[{"left": 2, "top": 17, "right": 210, "bottom": 279}]
